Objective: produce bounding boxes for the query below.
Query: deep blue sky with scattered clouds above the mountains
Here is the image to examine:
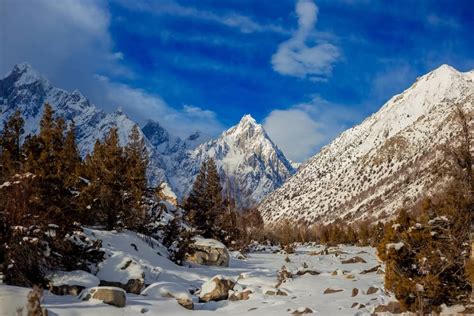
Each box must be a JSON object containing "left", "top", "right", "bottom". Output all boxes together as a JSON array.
[{"left": 0, "top": 0, "right": 474, "bottom": 161}]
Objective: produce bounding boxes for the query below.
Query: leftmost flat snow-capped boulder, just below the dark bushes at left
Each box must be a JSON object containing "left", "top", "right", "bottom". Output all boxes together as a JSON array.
[{"left": 46, "top": 270, "right": 100, "bottom": 295}]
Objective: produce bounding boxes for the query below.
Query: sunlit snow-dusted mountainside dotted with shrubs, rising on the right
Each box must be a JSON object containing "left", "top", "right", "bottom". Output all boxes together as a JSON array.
[{"left": 259, "top": 65, "right": 474, "bottom": 223}]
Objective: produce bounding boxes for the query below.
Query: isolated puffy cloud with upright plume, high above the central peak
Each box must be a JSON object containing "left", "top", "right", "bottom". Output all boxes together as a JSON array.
[{"left": 271, "top": 0, "right": 341, "bottom": 81}]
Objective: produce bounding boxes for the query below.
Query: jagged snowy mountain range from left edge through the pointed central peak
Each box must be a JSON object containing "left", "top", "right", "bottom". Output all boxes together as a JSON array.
[{"left": 0, "top": 63, "right": 295, "bottom": 202}]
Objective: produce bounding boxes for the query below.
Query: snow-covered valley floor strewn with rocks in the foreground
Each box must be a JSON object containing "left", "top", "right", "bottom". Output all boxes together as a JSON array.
[{"left": 0, "top": 230, "right": 393, "bottom": 316}]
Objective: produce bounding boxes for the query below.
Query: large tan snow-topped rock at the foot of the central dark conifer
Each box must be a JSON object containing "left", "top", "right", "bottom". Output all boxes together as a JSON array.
[{"left": 186, "top": 237, "right": 230, "bottom": 267}]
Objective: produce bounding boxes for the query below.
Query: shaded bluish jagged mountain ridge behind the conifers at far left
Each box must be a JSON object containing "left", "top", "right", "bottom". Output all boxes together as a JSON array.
[{"left": 0, "top": 63, "right": 165, "bottom": 183}]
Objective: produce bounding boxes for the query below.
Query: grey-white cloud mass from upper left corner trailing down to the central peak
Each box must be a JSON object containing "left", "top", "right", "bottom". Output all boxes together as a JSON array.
[{"left": 0, "top": 0, "right": 223, "bottom": 136}]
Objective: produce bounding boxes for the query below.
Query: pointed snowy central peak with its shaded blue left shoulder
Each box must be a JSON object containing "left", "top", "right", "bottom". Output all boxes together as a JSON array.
[{"left": 143, "top": 115, "right": 295, "bottom": 205}]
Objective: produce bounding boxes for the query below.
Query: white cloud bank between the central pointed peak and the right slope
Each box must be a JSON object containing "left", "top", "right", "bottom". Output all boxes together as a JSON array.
[{"left": 263, "top": 96, "right": 362, "bottom": 162}]
